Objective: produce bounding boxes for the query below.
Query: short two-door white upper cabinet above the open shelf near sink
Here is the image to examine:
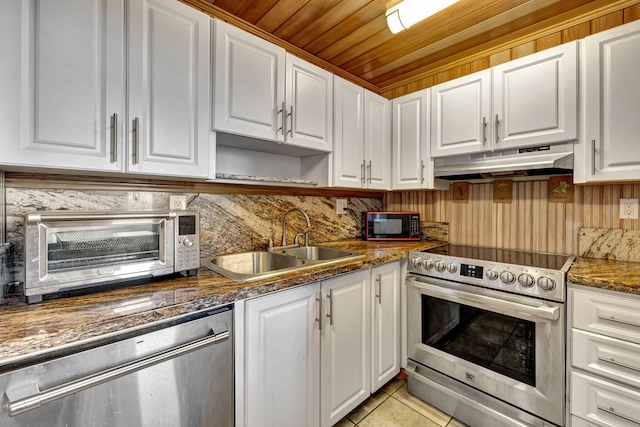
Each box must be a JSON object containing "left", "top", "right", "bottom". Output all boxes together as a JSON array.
[{"left": 213, "top": 20, "right": 333, "bottom": 152}]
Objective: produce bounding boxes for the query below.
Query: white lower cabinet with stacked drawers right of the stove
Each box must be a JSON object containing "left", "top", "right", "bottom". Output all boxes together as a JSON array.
[{"left": 568, "top": 286, "right": 640, "bottom": 427}]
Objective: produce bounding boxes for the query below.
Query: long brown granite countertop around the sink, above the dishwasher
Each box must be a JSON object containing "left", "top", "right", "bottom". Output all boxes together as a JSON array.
[{"left": 0, "top": 240, "right": 443, "bottom": 368}]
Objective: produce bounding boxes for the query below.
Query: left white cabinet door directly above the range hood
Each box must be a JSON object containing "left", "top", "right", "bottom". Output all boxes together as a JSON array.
[{"left": 431, "top": 70, "right": 493, "bottom": 157}]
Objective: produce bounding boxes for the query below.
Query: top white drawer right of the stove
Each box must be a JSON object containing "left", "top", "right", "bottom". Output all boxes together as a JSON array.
[{"left": 571, "top": 289, "right": 640, "bottom": 344}]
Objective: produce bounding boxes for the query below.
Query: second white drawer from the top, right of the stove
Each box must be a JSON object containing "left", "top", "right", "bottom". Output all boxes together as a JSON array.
[{"left": 571, "top": 329, "right": 640, "bottom": 388}]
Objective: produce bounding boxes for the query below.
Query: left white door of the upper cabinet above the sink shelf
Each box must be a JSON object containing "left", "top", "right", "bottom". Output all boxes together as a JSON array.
[{"left": 213, "top": 19, "right": 286, "bottom": 142}]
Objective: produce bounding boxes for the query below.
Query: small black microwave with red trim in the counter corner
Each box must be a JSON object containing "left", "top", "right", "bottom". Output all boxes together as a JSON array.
[{"left": 362, "top": 212, "right": 420, "bottom": 241}]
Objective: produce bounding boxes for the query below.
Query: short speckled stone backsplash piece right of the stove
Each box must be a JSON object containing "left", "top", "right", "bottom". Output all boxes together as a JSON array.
[{"left": 578, "top": 227, "right": 640, "bottom": 262}]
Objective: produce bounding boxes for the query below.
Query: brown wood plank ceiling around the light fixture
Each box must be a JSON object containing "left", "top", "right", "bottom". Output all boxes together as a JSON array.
[{"left": 182, "top": 0, "right": 635, "bottom": 93}]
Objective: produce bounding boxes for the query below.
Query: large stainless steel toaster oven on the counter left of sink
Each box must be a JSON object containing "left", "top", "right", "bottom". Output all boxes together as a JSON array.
[{"left": 24, "top": 211, "right": 200, "bottom": 303}]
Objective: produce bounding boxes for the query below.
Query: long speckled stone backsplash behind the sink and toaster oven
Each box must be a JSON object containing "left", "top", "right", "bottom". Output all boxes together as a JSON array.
[{"left": 6, "top": 188, "right": 382, "bottom": 290}]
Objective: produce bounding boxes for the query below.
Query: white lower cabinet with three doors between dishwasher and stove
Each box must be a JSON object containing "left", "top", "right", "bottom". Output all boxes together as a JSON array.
[{"left": 241, "top": 262, "right": 400, "bottom": 427}]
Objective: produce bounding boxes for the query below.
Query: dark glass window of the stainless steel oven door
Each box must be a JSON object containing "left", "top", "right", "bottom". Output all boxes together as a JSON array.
[{"left": 422, "top": 295, "right": 536, "bottom": 387}]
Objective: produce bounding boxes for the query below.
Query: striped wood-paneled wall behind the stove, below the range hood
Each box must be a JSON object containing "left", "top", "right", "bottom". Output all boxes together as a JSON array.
[{"left": 383, "top": 181, "right": 640, "bottom": 254}]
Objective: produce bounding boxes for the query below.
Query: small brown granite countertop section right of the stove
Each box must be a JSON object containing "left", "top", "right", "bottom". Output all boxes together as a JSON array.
[{"left": 567, "top": 257, "right": 640, "bottom": 295}]
